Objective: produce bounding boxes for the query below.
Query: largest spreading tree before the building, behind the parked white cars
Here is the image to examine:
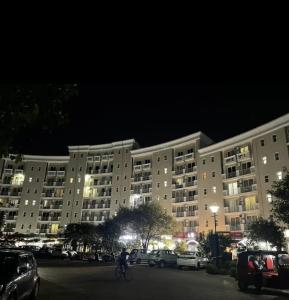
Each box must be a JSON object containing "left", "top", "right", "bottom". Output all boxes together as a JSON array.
[{"left": 117, "top": 203, "right": 176, "bottom": 249}]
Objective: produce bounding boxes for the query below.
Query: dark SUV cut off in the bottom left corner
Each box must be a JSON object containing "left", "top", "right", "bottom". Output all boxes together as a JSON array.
[{"left": 0, "top": 249, "right": 40, "bottom": 300}]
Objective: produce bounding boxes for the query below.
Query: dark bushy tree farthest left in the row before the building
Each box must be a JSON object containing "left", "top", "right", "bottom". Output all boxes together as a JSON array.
[{"left": 64, "top": 223, "right": 99, "bottom": 252}]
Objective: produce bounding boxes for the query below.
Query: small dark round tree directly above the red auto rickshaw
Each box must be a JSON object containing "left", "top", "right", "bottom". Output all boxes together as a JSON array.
[{"left": 249, "top": 218, "right": 285, "bottom": 250}]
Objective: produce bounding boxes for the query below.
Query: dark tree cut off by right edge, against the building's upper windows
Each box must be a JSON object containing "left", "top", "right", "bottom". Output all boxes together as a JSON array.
[{"left": 268, "top": 173, "right": 289, "bottom": 226}]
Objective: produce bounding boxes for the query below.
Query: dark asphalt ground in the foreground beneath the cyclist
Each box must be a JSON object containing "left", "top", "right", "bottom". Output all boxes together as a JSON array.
[{"left": 39, "top": 261, "right": 287, "bottom": 300}]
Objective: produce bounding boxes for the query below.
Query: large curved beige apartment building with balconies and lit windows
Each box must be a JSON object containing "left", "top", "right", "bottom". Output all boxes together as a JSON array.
[{"left": 0, "top": 114, "right": 289, "bottom": 238}]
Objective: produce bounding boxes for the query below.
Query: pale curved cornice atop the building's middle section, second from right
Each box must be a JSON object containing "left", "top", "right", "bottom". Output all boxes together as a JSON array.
[{"left": 131, "top": 131, "right": 211, "bottom": 156}]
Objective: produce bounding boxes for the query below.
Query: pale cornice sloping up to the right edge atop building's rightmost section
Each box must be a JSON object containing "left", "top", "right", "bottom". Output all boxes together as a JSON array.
[{"left": 198, "top": 113, "right": 289, "bottom": 155}]
